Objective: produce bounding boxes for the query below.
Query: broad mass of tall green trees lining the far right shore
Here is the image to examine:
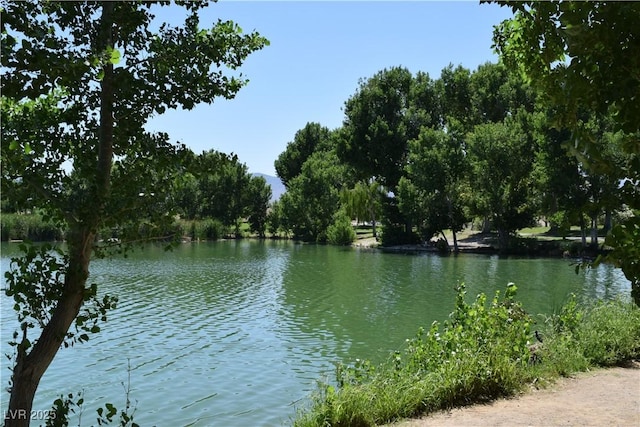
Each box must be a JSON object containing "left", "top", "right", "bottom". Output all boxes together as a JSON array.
[{"left": 272, "top": 63, "right": 632, "bottom": 251}]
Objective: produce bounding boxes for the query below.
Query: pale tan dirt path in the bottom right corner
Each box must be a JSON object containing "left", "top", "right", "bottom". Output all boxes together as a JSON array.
[{"left": 393, "top": 361, "right": 640, "bottom": 427}]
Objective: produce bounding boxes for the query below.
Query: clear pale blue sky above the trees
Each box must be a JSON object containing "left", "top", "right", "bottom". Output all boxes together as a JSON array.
[{"left": 147, "top": 0, "right": 511, "bottom": 176}]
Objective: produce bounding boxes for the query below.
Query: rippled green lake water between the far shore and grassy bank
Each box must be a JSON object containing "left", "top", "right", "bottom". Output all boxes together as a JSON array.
[{"left": 1, "top": 241, "right": 630, "bottom": 426}]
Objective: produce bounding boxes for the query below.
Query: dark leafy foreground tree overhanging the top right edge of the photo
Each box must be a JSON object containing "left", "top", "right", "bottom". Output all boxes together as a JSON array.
[{"left": 494, "top": 1, "right": 640, "bottom": 305}]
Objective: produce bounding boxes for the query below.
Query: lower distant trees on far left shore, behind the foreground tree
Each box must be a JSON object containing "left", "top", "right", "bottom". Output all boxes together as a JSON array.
[{"left": 0, "top": 150, "right": 271, "bottom": 241}]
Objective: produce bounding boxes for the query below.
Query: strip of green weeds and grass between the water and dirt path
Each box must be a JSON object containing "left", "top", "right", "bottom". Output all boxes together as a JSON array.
[{"left": 294, "top": 285, "right": 640, "bottom": 426}]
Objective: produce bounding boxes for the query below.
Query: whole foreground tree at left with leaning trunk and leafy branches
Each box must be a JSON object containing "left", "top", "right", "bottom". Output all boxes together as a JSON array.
[{"left": 1, "top": 1, "right": 267, "bottom": 426}]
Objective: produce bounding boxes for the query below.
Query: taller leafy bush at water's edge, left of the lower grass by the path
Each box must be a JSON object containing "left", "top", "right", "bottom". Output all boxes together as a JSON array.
[{"left": 295, "top": 285, "right": 531, "bottom": 426}]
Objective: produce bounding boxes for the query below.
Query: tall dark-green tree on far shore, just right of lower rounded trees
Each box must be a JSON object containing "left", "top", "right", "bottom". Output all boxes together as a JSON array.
[{"left": 337, "top": 67, "right": 444, "bottom": 244}]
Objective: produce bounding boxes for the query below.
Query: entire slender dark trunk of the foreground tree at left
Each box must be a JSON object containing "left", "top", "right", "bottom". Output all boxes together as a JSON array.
[{"left": 5, "top": 2, "right": 114, "bottom": 427}]
